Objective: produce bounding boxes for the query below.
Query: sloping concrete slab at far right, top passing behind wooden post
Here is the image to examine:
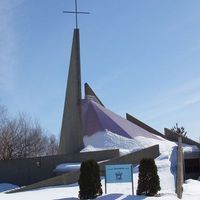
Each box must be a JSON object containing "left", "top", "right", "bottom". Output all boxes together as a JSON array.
[{"left": 165, "top": 128, "right": 200, "bottom": 148}]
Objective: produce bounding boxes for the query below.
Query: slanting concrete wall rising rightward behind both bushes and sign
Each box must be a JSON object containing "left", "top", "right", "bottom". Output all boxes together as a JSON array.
[{"left": 10, "top": 145, "right": 160, "bottom": 193}]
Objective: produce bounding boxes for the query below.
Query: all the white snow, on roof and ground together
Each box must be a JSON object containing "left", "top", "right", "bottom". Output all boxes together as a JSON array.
[{"left": 0, "top": 130, "right": 200, "bottom": 200}]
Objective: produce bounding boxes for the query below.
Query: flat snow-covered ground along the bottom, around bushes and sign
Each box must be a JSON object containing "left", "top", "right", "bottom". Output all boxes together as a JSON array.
[{"left": 0, "top": 179, "right": 200, "bottom": 200}]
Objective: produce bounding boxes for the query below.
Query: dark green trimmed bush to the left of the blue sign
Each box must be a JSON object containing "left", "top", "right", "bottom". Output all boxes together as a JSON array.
[{"left": 78, "top": 160, "right": 103, "bottom": 199}]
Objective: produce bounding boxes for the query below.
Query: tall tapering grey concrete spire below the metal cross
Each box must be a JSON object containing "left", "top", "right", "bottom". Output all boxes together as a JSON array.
[{"left": 58, "top": 29, "right": 83, "bottom": 154}]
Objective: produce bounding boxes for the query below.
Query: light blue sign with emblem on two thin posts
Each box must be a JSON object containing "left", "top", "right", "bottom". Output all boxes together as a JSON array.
[{"left": 105, "top": 164, "right": 134, "bottom": 195}]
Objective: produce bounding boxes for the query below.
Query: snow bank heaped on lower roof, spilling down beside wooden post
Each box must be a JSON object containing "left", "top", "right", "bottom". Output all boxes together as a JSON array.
[{"left": 83, "top": 130, "right": 177, "bottom": 194}]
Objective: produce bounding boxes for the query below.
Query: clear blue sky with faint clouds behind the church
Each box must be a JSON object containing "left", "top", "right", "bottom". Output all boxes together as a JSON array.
[{"left": 0, "top": 0, "right": 200, "bottom": 140}]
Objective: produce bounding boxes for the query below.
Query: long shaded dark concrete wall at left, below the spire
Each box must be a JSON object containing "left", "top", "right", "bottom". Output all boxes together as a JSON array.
[{"left": 0, "top": 149, "right": 119, "bottom": 186}]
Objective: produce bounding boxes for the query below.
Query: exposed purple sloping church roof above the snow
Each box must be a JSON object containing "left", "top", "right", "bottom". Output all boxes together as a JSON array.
[{"left": 82, "top": 99, "right": 160, "bottom": 140}]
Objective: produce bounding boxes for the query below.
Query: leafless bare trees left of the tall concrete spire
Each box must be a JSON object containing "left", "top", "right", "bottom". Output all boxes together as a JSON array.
[{"left": 0, "top": 106, "right": 58, "bottom": 160}]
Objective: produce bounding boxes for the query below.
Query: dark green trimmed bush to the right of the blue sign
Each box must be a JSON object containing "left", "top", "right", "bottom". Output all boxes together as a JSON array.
[{"left": 137, "top": 159, "right": 161, "bottom": 196}]
